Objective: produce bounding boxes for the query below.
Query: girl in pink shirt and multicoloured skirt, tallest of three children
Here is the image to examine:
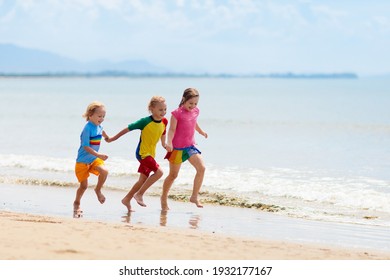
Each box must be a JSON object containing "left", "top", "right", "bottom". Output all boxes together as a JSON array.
[{"left": 161, "top": 88, "right": 207, "bottom": 210}]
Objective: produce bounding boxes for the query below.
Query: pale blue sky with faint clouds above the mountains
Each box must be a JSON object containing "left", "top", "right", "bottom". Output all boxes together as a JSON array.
[{"left": 0, "top": 0, "right": 390, "bottom": 75}]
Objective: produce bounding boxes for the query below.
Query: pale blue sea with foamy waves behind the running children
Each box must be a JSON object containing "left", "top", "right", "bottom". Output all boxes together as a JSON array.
[{"left": 0, "top": 77, "right": 390, "bottom": 227}]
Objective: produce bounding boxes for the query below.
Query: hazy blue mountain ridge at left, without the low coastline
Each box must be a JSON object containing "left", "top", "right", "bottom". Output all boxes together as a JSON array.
[{"left": 0, "top": 44, "right": 168, "bottom": 74}]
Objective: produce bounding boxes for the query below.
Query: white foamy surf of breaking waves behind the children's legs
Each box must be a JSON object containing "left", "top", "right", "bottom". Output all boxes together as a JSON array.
[{"left": 0, "top": 154, "right": 390, "bottom": 225}]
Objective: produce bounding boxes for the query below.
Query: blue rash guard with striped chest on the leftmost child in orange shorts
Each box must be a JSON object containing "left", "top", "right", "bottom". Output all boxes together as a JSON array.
[{"left": 76, "top": 121, "right": 103, "bottom": 164}]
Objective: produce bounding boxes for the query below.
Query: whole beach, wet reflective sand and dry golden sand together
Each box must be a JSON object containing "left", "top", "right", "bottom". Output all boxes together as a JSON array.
[{"left": 0, "top": 184, "right": 390, "bottom": 260}]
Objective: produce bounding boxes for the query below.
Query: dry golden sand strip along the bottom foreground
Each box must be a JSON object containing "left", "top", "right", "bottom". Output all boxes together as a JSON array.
[{"left": 0, "top": 212, "right": 390, "bottom": 260}]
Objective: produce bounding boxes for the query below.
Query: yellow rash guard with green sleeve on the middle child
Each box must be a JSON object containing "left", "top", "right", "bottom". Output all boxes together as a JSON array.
[{"left": 128, "top": 116, "right": 168, "bottom": 160}]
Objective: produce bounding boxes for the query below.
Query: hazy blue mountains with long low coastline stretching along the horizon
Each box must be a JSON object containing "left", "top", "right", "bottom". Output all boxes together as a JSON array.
[{"left": 0, "top": 44, "right": 358, "bottom": 79}]
